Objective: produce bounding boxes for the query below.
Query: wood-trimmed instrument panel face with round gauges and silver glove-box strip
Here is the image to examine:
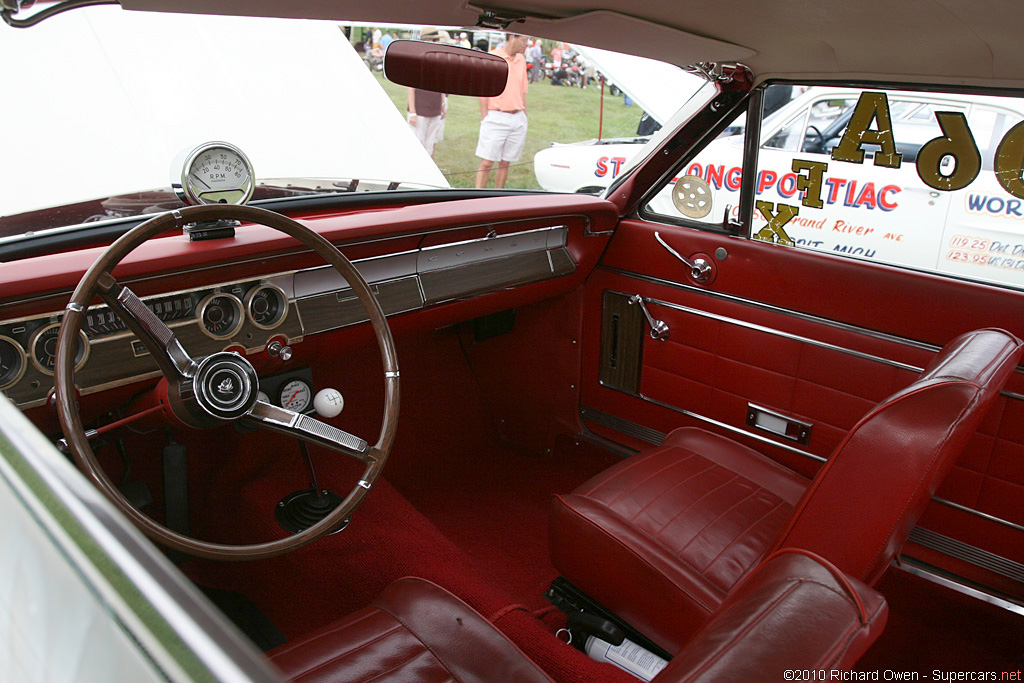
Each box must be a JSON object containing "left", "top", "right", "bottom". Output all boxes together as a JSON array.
[{"left": 0, "top": 200, "right": 606, "bottom": 410}]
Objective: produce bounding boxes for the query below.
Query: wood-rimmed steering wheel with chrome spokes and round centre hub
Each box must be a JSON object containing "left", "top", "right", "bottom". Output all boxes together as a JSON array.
[{"left": 54, "top": 205, "right": 398, "bottom": 560}]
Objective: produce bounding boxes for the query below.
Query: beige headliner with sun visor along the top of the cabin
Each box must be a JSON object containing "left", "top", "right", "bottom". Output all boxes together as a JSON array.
[{"left": 122, "top": 0, "right": 1024, "bottom": 87}]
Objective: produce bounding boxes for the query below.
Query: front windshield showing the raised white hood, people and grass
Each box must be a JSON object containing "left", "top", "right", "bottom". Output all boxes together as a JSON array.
[{"left": 0, "top": 6, "right": 706, "bottom": 240}]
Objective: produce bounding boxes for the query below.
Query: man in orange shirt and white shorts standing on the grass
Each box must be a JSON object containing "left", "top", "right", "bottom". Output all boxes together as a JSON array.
[{"left": 476, "top": 33, "right": 527, "bottom": 187}]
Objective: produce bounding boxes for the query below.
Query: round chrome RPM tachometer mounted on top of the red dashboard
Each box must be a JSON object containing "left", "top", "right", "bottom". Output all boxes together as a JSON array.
[{"left": 172, "top": 142, "right": 255, "bottom": 204}]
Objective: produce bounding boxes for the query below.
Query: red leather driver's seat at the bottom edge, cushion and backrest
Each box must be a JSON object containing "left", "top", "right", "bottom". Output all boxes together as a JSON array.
[{"left": 269, "top": 551, "right": 888, "bottom": 683}]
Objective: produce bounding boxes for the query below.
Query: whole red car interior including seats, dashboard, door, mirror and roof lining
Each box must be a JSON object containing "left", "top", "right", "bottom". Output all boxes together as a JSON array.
[{"left": 0, "top": 0, "right": 1024, "bottom": 683}]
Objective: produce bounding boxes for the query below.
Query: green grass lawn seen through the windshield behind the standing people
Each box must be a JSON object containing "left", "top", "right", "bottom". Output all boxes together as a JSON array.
[{"left": 374, "top": 72, "right": 643, "bottom": 189}]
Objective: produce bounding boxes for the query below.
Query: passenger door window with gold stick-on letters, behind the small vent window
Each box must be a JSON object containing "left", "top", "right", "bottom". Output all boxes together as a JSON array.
[{"left": 743, "top": 86, "right": 1024, "bottom": 288}]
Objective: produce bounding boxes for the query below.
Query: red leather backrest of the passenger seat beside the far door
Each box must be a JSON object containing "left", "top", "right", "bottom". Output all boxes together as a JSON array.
[{"left": 774, "top": 330, "right": 1022, "bottom": 584}]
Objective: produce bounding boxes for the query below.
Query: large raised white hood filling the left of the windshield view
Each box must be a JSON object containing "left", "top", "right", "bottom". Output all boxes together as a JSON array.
[{"left": 0, "top": 7, "right": 449, "bottom": 215}]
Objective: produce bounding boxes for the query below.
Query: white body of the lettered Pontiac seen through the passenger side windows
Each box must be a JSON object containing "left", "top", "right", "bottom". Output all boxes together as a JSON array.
[{"left": 643, "top": 87, "right": 1024, "bottom": 287}]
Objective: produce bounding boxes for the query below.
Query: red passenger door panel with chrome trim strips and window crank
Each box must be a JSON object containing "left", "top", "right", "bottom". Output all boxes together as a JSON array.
[{"left": 582, "top": 220, "right": 1024, "bottom": 595}]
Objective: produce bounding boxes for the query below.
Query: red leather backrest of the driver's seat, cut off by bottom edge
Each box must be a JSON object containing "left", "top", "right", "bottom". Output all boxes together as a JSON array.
[{"left": 652, "top": 550, "right": 889, "bottom": 683}]
